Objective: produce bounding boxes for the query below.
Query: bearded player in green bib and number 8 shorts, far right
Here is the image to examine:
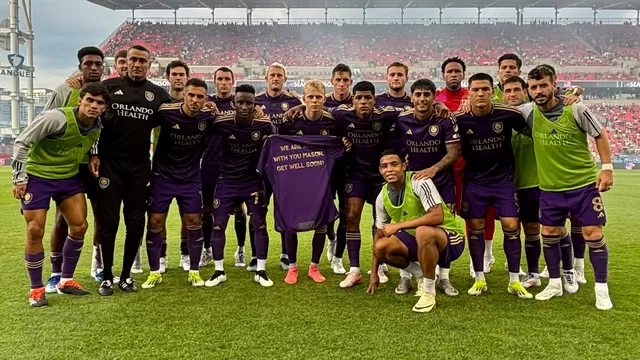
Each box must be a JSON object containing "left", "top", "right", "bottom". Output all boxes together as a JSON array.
[{"left": 523, "top": 65, "right": 613, "bottom": 310}]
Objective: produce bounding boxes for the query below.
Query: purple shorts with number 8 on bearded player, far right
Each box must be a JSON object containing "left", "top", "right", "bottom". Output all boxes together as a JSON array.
[{"left": 540, "top": 183, "right": 607, "bottom": 226}]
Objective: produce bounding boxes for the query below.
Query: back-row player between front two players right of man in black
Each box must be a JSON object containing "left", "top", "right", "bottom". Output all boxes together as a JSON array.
[{"left": 200, "top": 67, "right": 252, "bottom": 271}]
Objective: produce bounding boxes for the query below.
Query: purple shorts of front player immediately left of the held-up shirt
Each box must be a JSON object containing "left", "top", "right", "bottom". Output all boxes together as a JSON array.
[{"left": 213, "top": 181, "right": 267, "bottom": 229}]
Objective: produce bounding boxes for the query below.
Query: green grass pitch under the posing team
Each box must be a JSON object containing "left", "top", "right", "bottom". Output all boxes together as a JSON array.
[{"left": 0, "top": 167, "right": 640, "bottom": 359}]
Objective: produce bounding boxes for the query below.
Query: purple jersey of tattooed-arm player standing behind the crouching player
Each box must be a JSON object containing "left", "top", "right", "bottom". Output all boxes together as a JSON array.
[{"left": 396, "top": 109, "right": 460, "bottom": 188}]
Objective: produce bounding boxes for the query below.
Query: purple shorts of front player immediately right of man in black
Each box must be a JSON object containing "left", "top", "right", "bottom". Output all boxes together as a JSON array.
[{"left": 148, "top": 176, "right": 202, "bottom": 214}]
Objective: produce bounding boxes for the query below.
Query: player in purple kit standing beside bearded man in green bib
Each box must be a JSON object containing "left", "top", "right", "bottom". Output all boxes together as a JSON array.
[{"left": 456, "top": 73, "right": 533, "bottom": 299}]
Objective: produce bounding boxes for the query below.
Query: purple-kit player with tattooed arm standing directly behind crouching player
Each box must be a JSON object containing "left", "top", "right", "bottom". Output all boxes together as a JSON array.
[{"left": 396, "top": 79, "right": 460, "bottom": 296}]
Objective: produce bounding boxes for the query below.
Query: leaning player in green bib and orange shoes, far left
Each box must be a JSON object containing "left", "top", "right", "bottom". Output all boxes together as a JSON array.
[{"left": 12, "top": 83, "right": 109, "bottom": 307}]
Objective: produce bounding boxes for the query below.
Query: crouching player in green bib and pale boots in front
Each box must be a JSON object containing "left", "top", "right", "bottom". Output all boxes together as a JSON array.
[{"left": 367, "top": 150, "right": 464, "bottom": 312}]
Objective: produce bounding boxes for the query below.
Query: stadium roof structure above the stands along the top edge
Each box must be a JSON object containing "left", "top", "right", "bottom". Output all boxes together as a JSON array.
[{"left": 88, "top": 0, "right": 640, "bottom": 10}]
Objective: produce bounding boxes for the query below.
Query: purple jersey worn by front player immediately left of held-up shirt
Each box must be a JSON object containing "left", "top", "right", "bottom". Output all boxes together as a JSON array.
[{"left": 213, "top": 111, "right": 275, "bottom": 183}]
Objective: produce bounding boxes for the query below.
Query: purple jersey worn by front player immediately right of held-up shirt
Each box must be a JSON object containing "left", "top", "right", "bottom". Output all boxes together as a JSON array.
[{"left": 331, "top": 105, "right": 400, "bottom": 182}]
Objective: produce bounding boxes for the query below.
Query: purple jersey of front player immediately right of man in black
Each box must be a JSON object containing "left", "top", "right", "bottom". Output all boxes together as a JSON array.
[{"left": 153, "top": 102, "right": 215, "bottom": 183}]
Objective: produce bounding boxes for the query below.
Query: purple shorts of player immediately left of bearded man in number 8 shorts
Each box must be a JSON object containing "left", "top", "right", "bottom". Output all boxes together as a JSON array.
[{"left": 460, "top": 182, "right": 520, "bottom": 219}]
